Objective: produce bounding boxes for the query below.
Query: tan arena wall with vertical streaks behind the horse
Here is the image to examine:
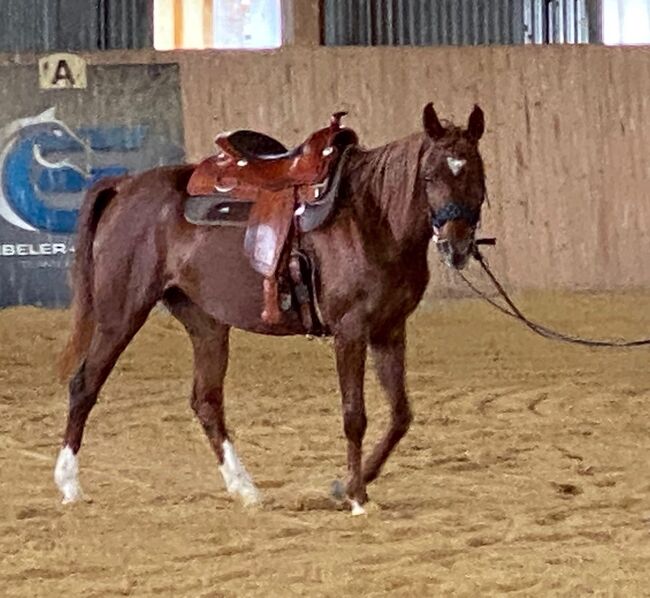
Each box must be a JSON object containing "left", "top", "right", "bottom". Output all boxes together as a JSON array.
[{"left": 0, "top": 46, "right": 650, "bottom": 300}]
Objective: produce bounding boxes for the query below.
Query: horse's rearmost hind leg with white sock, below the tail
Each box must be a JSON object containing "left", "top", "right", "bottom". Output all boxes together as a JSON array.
[{"left": 54, "top": 304, "right": 153, "bottom": 503}]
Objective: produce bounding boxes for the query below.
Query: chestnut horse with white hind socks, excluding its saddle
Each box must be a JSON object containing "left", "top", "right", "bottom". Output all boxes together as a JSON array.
[{"left": 54, "top": 104, "right": 485, "bottom": 514}]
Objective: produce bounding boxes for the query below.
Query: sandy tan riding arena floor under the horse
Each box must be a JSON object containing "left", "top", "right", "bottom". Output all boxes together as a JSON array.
[{"left": 0, "top": 295, "right": 650, "bottom": 598}]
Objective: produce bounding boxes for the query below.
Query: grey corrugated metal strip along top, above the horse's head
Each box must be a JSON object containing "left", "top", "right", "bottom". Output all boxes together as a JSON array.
[{"left": 322, "top": 0, "right": 601, "bottom": 46}]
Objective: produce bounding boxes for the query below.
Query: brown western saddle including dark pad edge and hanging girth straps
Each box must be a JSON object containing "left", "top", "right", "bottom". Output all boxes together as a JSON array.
[{"left": 187, "top": 112, "right": 358, "bottom": 330}]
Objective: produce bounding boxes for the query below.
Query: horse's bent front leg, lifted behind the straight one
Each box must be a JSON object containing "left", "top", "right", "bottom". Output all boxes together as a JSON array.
[{"left": 363, "top": 324, "right": 413, "bottom": 484}]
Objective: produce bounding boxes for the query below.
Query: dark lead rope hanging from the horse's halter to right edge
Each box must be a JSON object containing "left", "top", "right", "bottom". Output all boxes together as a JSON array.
[{"left": 457, "top": 242, "right": 650, "bottom": 347}]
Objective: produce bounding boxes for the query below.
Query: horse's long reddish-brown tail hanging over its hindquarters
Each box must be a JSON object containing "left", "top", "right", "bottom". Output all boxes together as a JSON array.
[{"left": 59, "top": 177, "right": 121, "bottom": 382}]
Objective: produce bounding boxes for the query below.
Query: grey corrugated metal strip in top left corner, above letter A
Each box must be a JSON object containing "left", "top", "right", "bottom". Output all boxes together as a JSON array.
[{"left": 0, "top": 0, "right": 153, "bottom": 52}]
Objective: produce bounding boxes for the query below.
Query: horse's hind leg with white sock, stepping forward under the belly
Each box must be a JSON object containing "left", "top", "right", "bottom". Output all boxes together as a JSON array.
[{"left": 165, "top": 291, "right": 260, "bottom": 505}]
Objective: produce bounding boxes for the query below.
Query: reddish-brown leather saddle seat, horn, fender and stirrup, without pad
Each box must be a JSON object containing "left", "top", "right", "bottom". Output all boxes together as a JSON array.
[{"left": 187, "top": 112, "right": 358, "bottom": 322}]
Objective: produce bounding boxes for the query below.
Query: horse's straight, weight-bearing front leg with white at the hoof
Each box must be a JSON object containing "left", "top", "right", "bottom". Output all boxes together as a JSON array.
[{"left": 335, "top": 335, "right": 368, "bottom": 515}]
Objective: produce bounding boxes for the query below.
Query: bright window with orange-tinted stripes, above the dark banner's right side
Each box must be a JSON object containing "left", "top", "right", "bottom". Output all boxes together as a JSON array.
[{"left": 154, "top": 0, "right": 282, "bottom": 50}]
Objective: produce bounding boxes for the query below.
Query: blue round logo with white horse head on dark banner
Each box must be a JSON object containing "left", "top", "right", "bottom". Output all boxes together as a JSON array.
[{"left": 0, "top": 108, "right": 132, "bottom": 233}]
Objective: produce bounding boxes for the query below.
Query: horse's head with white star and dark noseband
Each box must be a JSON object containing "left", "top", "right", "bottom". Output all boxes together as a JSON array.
[{"left": 420, "top": 103, "right": 485, "bottom": 268}]
